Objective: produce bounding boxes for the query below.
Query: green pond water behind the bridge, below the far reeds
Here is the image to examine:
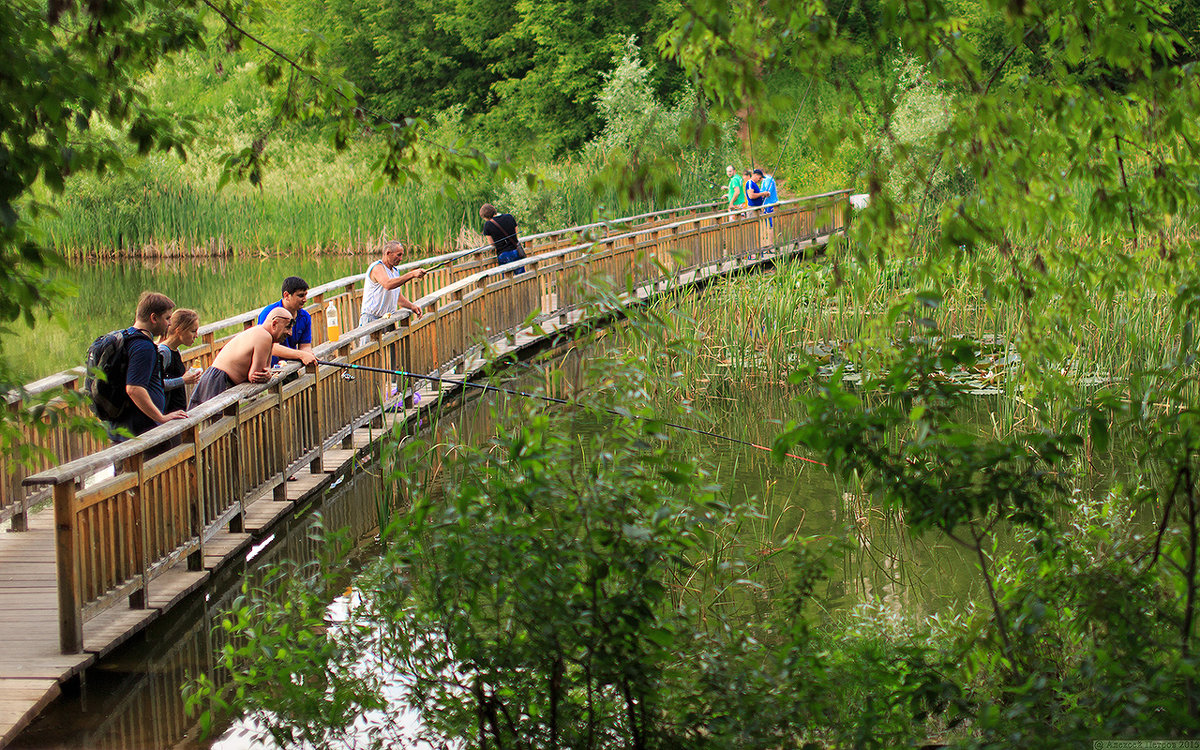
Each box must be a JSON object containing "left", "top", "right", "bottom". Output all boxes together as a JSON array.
[{"left": 0, "top": 254, "right": 373, "bottom": 383}]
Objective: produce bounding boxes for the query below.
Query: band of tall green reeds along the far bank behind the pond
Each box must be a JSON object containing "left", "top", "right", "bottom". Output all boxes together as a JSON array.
[{"left": 42, "top": 133, "right": 712, "bottom": 260}]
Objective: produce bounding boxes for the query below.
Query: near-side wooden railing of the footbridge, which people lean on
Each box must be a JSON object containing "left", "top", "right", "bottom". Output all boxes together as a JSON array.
[{"left": 14, "top": 191, "right": 848, "bottom": 653}]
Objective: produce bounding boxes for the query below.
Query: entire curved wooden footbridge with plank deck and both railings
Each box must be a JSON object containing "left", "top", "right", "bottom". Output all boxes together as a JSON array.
[{"left": 0, "top": 191, "right": 848, "bottom": 746}]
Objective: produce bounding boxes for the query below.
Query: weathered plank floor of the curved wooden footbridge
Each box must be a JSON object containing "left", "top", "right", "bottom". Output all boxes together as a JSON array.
[{"left": 0, "top": 238, "right": 827, "bottom": 748}]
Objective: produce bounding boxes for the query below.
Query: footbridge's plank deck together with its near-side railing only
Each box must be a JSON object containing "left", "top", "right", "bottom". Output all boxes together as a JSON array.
[{"left": 0, "top": 193, "right": 845, "bottom": 748}]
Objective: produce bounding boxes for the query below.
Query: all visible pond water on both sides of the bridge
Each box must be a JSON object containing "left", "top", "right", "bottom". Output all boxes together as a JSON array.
[{"left": 4, "top": 238, "right": 1152, "bottom": 750}]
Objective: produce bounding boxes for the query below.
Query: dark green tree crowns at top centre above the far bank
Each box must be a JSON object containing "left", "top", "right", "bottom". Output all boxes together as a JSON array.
[{"left": 300, "top": 0, "right": 682, "bottom": 155}]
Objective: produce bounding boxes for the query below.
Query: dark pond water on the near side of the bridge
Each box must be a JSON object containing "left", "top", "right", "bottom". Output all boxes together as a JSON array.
[{"left": 12, "top": 338, "right": 1070, "bottom": 750}]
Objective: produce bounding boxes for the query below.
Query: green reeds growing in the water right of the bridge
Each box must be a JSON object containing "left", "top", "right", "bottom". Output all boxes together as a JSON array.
[{"left": 629, "top": 236, "right": 1195, "bottom": 430}]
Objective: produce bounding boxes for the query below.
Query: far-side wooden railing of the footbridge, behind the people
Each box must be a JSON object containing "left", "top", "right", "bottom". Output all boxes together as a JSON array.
[{"left": 0, "top": 195, "right": 718, "bottom": 532}]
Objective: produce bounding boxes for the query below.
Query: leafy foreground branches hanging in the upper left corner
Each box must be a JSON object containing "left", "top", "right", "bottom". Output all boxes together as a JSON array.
[{"left": 0, "top": 0, "right": 511, "bottom": 472}]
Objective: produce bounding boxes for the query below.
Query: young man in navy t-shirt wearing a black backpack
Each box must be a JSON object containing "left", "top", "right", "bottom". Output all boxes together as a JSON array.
[{"left": 108, "top": 292, "right": 187, "bottom": 443}]
